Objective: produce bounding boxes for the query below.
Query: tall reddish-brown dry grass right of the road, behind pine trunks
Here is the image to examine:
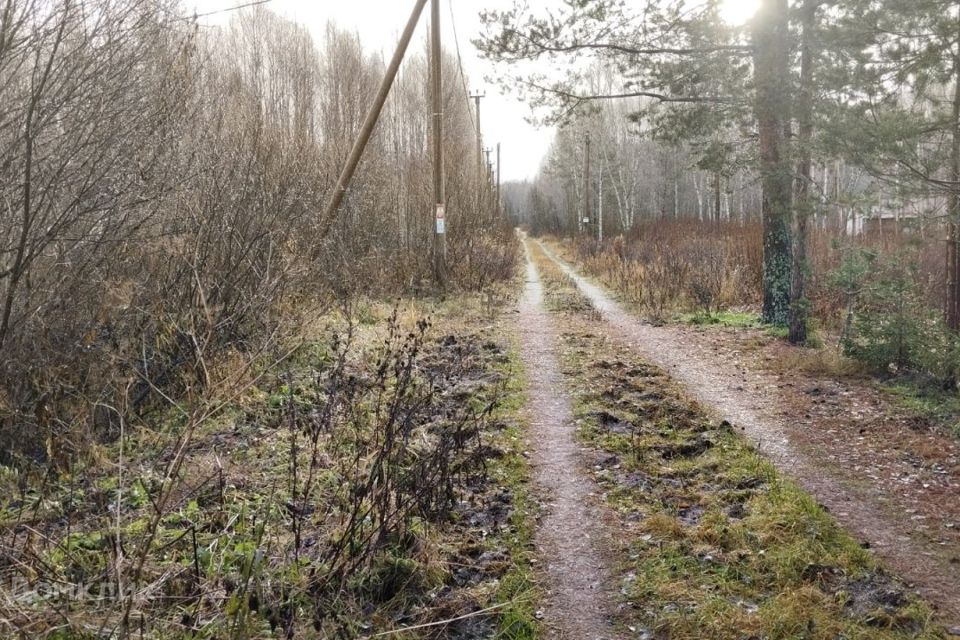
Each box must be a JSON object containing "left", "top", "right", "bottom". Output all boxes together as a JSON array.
[{"left": 566, "top": 220, "right": 945, "bottom": 329}]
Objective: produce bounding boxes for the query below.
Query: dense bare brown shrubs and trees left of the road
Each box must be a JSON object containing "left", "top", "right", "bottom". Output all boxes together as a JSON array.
[{"left": 0, "top": 0, "right": 516, "bottom": 462}]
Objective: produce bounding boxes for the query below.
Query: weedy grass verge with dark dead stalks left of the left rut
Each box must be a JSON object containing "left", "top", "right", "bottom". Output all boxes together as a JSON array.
[{"left": 0, "top": 296, "right": 539, "bottom": 640}]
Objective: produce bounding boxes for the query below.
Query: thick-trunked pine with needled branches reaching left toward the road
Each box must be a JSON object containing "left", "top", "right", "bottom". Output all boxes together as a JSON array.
[{"left": 476, "top": 0, "right": 793, "bottom": 325}]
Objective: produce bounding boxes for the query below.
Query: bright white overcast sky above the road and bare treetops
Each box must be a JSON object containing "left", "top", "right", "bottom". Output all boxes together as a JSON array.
[{"left": 186, "top": 0, "right": 757, "bottom": 181}]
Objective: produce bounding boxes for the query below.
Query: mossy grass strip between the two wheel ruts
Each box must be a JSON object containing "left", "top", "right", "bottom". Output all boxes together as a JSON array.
[{"left": 531, "top": 239, "right": 944, "bottom": 640}]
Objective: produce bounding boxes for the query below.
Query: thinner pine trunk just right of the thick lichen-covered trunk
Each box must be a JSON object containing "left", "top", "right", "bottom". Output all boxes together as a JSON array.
[{"left": 790, "top": 0, "right": 820, "bottom": 344}]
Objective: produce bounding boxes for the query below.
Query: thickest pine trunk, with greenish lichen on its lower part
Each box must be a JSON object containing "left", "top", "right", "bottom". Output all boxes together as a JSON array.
[{"left": 753, "top": 0, "right": 793, "bottom": 326}]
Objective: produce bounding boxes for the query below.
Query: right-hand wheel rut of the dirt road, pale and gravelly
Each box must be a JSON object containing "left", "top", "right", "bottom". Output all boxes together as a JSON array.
[{"left": 541, "top": 240, "right": 960, "bottom": 625}]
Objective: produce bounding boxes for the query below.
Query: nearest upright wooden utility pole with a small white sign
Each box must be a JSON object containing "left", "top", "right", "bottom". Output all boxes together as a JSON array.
[{"left": 430, "top": 0, "right": 447, "bottom": 286}]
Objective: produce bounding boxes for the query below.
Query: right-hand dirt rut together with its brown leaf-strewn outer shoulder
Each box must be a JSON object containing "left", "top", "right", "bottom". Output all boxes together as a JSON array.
[{"left": 544, "top": 241, "right": 960, "bottom": 625}]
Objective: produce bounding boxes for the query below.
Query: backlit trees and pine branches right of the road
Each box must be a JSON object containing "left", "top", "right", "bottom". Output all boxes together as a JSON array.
[{"left": 477, "top": 0, "right": 960, "bottom": 350}]
